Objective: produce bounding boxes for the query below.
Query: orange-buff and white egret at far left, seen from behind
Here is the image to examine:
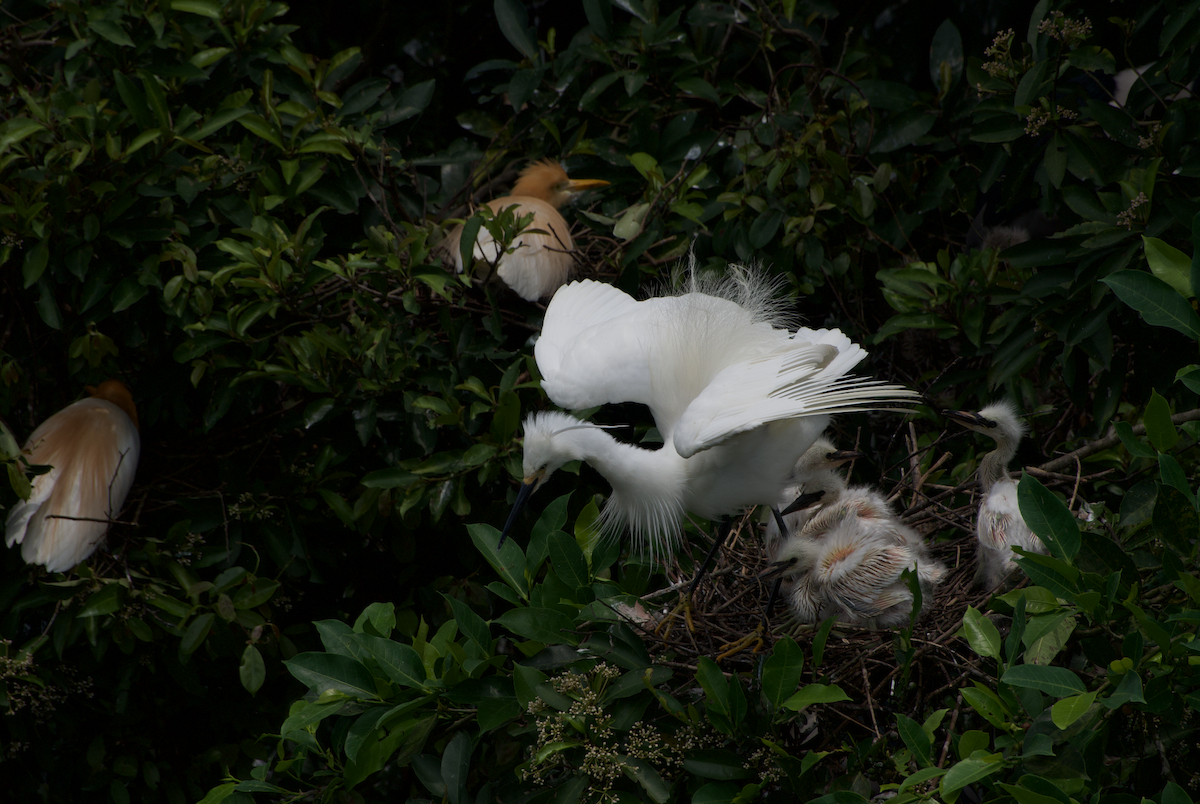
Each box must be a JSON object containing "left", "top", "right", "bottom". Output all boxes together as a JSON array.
[{"left": 5, "top": 379, "right": 140, "bottom": 572}]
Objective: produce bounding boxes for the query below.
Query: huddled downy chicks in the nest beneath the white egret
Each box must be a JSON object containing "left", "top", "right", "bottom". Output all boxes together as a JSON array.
[{"left": 766, "top": 439, "right": 946, "bottom": 628}]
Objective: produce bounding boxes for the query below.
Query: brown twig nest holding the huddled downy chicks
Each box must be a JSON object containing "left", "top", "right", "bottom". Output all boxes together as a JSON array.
[{"left": 604, "top": 441, "right": 1108, "bottom": 751}]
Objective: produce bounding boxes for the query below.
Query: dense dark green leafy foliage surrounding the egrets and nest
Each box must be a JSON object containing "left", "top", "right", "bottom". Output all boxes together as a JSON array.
[{"left": 0, "top": 0, "right": 1200, "bottom": 804}]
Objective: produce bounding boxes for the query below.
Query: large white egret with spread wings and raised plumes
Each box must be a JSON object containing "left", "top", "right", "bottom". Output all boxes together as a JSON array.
[{"left": 502, "top": 266, "right": 917, "bottom": 571}]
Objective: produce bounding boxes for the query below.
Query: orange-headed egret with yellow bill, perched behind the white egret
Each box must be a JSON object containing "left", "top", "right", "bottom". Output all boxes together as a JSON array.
[{"left": 444, "top": 160, "right": 608, "bottom": 301}]
